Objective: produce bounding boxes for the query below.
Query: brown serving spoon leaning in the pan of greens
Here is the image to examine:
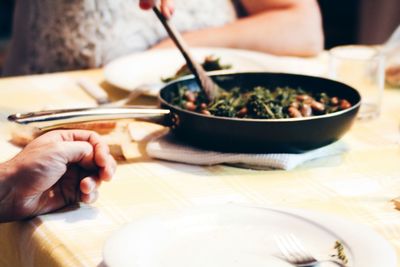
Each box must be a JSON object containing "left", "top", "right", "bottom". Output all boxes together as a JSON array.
[{"left": 153, "top": 7, "right": 220, "bottom": 101}]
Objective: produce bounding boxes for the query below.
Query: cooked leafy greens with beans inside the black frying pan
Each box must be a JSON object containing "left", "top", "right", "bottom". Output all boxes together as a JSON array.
[{"left": 171, "top": 86, "right": 351, "bottom": 119}]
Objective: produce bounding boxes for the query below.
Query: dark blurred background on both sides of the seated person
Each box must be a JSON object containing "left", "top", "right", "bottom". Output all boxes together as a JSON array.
[{"left": 0, "top": 0, "right": 400, "bottom": 73}]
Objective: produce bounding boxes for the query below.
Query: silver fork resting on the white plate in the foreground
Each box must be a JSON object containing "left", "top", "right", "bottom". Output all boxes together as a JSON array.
[{"left": 275, "top": 234, "right": 346, "bottom": 267}]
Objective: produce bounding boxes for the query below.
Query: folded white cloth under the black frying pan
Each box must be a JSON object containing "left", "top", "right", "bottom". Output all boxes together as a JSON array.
[{"left": 146, "top": 134, "right": 347, "bottom": 170}]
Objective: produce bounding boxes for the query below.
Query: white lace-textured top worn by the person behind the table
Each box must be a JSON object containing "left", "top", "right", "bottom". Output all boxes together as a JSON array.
[{"left": 4, "top": 0, "right": 236, "bottom": 75}]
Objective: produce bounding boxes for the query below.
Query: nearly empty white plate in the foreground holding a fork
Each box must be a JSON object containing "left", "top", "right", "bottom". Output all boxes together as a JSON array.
[{"left": 103, "top": 205, "right": 396, "bottom": 267}]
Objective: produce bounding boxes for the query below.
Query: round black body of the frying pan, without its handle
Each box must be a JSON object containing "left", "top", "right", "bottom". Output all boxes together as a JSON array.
[{"left": 159, "top": 72, "right": 361, "bottom": 153}]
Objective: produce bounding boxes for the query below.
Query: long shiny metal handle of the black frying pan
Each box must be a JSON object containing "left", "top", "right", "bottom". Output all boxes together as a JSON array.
[{"left": 8, "top": 106, "right": 170, "bottom": 131}]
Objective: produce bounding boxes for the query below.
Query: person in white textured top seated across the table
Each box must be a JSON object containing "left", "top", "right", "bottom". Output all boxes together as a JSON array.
[{"left": 3, "top": 0, "right": 323, "bottom": 76}]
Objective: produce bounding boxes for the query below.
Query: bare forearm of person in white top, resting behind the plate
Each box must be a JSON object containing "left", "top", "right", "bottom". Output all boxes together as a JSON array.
[{"left": 152, "top": 0, "right": 323, "bottom": 56}]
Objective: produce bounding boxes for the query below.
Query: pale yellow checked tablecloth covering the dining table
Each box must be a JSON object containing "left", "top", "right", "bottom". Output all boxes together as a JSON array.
[{"left": 0, "top": 63, "right": 400, "bottom": 266}]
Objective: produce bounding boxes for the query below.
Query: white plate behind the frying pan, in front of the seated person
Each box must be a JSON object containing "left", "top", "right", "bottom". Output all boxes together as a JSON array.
[{"left": 104, "top": 48, "right": 326, "bottom": 95}]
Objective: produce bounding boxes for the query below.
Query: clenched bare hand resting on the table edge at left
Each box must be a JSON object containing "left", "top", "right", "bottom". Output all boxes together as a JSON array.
[{"left": 0, "top": 130, "right": 116, "bottom": 222}]
